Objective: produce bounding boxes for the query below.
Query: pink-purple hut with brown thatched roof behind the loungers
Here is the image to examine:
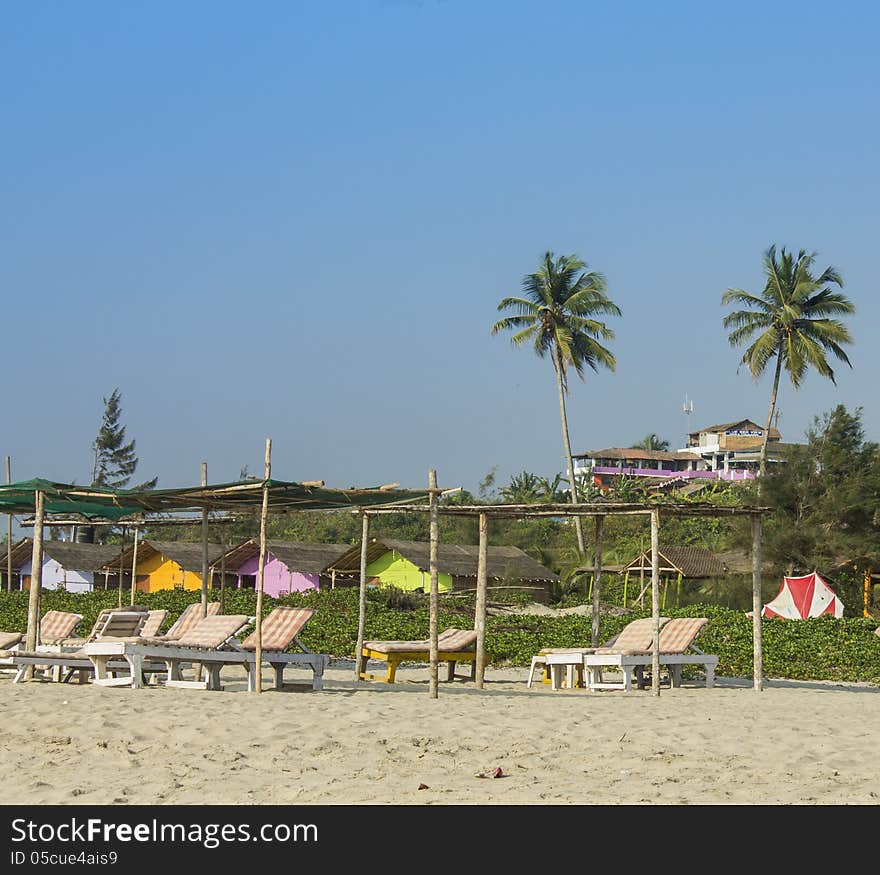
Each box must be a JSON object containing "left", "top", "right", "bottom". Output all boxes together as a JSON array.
[{"left": 213, "top": 538, "right": 351, "bottom": 598}]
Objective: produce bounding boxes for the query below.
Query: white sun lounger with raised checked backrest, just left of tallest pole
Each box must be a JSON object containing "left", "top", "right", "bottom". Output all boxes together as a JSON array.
[{"left": 84, "top": 614, "right": 254, "bottom": 690}]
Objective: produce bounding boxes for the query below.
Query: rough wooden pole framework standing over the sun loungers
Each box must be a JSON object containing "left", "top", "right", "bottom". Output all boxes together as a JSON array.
[{"left": 0, "top": 452, "right": 770, "bottom": 698}]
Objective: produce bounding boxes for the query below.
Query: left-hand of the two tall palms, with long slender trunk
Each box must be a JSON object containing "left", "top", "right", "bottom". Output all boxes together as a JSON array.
[{"left": 492, "top": 252, "right": 620, "bottom": 553}]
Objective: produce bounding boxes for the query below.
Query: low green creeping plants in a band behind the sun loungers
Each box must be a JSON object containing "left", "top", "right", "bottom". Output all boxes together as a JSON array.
[{"left": 0, "top": 587, "right": 880, "bottom": 683}]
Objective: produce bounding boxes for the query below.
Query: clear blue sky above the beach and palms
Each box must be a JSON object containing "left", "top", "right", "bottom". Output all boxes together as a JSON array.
[{"left": 0, "top": 0, "right": 880, "bottom": 489}]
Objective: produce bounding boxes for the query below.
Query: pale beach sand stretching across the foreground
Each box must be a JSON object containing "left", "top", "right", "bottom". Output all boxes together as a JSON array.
[{"left": 0, "top": 662, "right": 880, "bottom": 805}]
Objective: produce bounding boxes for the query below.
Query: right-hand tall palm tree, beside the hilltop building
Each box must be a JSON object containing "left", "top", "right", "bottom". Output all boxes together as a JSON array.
[{"left": 721, "top": 244, "right": 855, "bottom": 476}]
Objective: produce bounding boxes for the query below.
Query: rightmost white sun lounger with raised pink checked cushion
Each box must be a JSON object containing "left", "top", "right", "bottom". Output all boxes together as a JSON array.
[{"left": 584, "top": 617, "right": 718, "bottom": 690}]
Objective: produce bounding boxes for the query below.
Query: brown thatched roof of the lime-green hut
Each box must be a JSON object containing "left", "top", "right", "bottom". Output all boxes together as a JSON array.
[{"left": 327, "top": 538, "right": 559, "bottom": 581}]
